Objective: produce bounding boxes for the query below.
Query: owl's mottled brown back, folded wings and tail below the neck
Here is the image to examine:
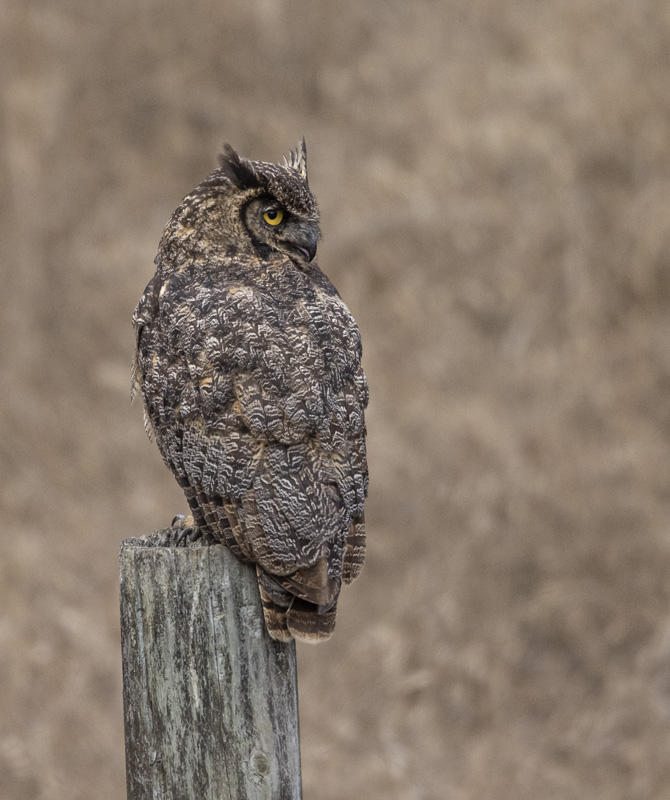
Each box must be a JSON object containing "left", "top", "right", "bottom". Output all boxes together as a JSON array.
[{"left": 140, "top": 266, "right": 367, "bottom": 638}]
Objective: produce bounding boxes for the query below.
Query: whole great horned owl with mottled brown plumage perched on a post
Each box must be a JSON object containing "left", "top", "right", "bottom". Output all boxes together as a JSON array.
[{"left": 133, "top": 139, "right": 368, "bottom": 641}]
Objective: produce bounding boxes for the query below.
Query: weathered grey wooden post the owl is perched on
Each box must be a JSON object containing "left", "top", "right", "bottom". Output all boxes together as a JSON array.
[{"left": 120, "top": 530, "right": 301, "bottom": 800}]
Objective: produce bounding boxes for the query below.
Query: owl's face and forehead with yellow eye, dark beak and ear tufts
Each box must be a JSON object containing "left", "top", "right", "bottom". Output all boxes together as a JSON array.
[{"left": 219, "top": 139, "right": 320, "bottom": 264}]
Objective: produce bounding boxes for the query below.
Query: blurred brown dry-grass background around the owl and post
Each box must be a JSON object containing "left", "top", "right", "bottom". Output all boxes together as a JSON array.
[{"left": 0, "top": 0, "right": 670, "bottom": 800}]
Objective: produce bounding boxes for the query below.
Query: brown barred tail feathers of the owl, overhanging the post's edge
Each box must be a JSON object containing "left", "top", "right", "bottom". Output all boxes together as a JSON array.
[{"left": 256, "top": 565, "right": 339, "bottom": 643}]
